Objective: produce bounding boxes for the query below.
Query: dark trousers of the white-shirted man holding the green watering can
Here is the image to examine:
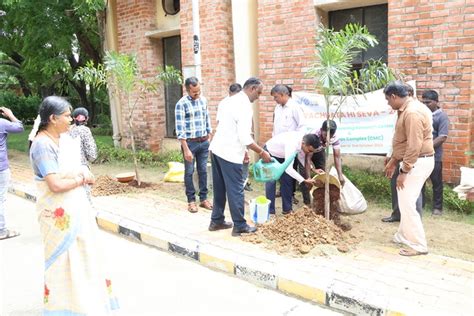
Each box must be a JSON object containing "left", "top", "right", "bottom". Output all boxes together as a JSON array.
[{"left": 211, "top": 154, "right": 247, "bottom": 229}]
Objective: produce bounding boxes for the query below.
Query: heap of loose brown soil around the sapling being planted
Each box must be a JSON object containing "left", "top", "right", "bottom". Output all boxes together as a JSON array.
[{"left": 242, "top": 207, "right": 357, "bottom": 254}]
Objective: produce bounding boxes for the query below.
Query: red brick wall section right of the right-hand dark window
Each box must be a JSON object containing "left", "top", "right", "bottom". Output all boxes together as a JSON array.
[{"left": 388, "top": 0, "right": 474, "bottom": 183}]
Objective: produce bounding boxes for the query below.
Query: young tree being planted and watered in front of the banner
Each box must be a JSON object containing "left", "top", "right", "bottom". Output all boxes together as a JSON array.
[{"left": 307, "top": 24, "right": 396, "bottom": 219}]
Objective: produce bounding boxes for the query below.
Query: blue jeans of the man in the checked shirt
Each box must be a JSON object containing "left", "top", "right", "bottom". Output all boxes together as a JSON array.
[{"left": 184, "top": 141, "right": 209, "bottom": 203}]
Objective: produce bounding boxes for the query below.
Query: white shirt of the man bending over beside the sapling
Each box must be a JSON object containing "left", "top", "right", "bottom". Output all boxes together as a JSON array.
[{"left": 266, "top": 131, "right": 305, "bottom": 183}]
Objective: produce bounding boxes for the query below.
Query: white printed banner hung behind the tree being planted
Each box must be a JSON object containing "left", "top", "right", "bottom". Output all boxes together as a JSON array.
[{"left": 293, "top": 81, "right": 415, "bottom": 154}]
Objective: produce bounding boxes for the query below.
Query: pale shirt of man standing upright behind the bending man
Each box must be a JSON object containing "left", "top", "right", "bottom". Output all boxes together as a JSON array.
[{"left": 272, "top": 98, "right": 305, "bottom": 136}]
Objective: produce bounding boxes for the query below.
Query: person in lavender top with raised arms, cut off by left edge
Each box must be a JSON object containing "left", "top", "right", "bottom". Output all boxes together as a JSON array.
[{"left": 0, "top": 106, "right": 23, "bottom": 240}]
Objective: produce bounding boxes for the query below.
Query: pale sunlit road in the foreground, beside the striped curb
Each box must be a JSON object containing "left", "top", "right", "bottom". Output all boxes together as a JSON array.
[{"left": 0, "top": 194, "right": 341, "bottom": 316}]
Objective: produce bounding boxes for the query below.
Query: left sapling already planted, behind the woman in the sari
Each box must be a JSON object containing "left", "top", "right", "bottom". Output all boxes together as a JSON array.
[{"left": 75, "top": 52, "right": 182, "bottom": 186}]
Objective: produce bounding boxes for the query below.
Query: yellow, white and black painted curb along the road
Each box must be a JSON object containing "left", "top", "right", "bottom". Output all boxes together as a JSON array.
[{"left": 8, "top": 182, "right": 405, "bottom": 316}]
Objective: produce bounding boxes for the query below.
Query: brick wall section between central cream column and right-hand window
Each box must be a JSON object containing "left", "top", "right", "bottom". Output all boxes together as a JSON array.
[{"left": 255, "top": 0, "right": 316, "bottom": 143}]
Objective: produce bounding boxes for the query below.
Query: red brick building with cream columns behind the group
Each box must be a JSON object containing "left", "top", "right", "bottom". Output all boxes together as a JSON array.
[{"left": 106, "top": 0, "right": 474, "bottom": 182}]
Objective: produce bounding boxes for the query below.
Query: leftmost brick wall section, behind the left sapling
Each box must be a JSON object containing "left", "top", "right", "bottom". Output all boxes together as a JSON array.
[{"left": 117, "top": 0, "right": 165, "bottom": 151}]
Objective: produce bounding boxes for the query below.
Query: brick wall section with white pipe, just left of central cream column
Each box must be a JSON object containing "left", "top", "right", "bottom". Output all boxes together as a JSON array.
[{"left": 180, "top": 0, "right": 235, "bottom": 128}]
